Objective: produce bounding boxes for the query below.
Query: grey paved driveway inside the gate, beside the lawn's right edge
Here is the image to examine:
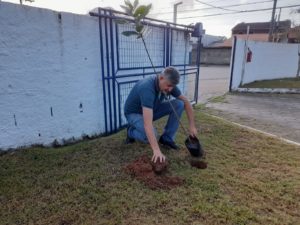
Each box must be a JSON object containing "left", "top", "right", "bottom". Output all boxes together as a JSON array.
[{"left": 207, "top": 94, "right": 300, "bottom": 142}]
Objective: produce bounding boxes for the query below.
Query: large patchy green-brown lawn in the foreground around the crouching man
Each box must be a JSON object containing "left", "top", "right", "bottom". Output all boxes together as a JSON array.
[{"left": 0, "top": 112, "right": 300, "bottom": 225}]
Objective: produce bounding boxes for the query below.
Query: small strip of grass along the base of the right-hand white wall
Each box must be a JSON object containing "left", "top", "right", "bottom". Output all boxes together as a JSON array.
[{"left": 242, "top": 78, "right": 300, "bottom": 88}]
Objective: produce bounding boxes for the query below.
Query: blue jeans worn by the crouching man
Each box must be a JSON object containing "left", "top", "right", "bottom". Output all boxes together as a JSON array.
[{"left": 125, "top": 99, "right": 184, "bottom": 143}]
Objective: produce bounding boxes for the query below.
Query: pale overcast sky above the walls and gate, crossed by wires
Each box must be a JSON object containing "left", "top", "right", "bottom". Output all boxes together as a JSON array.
[{"left": 0, "top": 0, "right": 300, "bottom": 37}]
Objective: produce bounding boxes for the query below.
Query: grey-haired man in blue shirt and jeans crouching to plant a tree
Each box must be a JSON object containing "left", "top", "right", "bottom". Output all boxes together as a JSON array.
[{"left": 124, "top": 67, "right": 197, "bottom": 162}]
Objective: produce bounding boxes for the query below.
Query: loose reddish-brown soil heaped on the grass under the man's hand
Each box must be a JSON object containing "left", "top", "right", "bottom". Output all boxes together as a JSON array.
[{"left": 125, "top": 155, "right": 184, "bottom": 190}]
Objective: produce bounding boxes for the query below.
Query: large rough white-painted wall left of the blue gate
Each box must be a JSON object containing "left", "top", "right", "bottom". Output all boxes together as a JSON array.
[{"left": 0, "top": 2, "right": 104, "bottom": 149}]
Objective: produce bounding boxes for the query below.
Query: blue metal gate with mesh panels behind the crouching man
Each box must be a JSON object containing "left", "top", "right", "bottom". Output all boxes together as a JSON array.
[{"left": 90, "top": 8, "right": 200, "bottom": 134}]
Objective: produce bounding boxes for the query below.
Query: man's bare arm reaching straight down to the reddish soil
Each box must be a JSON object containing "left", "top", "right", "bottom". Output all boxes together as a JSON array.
[{"left": 143, "top": 107, "right": 165, "bottom": 162}]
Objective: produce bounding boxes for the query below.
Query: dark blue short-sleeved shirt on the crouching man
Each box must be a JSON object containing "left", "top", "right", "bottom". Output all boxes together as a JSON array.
[{"left": 124, "top": 76, "right": 181, "bottom": 115}]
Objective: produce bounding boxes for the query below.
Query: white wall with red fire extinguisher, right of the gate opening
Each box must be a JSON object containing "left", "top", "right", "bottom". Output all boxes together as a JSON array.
[{"left": 231, "top": 39, "right": 299, "bottom": 90}]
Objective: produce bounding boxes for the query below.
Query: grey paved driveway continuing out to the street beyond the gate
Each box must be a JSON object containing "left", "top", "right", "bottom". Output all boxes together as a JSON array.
[{"left": 198, "top": 66, "right": 300, "bottom": 142}]
